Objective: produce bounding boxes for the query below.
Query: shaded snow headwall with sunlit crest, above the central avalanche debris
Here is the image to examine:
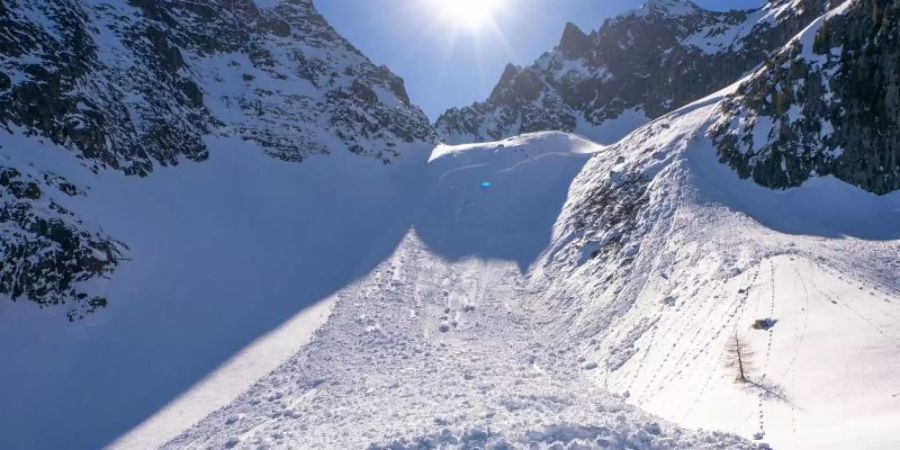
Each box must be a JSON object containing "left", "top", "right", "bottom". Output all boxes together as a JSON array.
[{"left": 415, "top": 132, "right": 603, "bottom": 271}]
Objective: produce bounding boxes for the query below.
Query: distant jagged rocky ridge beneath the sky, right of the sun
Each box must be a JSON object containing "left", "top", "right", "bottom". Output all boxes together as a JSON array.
[{"left": 437, "top": 0, "right": 827, "bottom": 143}]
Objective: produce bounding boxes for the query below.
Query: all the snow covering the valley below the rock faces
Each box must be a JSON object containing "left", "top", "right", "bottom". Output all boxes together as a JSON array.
[{"left": 0, "top": 2, "right": 900, "bottom": 449}]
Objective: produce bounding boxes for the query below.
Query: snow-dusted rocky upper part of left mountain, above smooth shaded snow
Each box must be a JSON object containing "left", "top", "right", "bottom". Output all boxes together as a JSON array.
[{"left": 0, "top": 0, "right": 432, "bottom": 169}]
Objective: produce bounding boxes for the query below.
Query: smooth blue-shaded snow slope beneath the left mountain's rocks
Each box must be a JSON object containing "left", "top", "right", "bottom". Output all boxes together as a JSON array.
[{"left": 0, "top": 130, "right": 429, "bottom": 449}]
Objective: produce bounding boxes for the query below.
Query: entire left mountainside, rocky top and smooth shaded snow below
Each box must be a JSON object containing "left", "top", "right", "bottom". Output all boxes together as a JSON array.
[{"left": 0, "top": 0, "right": 448, "bottom": 449}]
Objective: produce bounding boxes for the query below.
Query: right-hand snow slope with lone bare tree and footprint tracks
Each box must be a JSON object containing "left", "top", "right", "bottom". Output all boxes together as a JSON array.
[{"left": 529, "top": 87, "right": 900, "bottom": 449}]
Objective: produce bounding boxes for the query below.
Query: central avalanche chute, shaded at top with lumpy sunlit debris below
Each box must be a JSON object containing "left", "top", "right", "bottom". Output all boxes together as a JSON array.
[{"left": 164, "top": 133, "right": 756, "bottom": 449}]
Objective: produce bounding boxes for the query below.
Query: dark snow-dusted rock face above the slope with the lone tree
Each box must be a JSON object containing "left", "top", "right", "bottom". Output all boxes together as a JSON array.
[{"left": 712, "top": 0, "right": 900, "bottom": 194}]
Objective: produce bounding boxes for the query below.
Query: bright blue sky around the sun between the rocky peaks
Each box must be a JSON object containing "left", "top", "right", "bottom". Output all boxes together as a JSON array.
[{"left": 315, "top": 0, "right": 764, "bottom": 119}]
